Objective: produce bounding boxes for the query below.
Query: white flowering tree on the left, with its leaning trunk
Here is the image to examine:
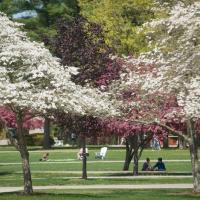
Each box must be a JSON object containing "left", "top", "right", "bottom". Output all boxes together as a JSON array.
[{"left": 0, "top": 13, "right": 117, "bottom": 194}]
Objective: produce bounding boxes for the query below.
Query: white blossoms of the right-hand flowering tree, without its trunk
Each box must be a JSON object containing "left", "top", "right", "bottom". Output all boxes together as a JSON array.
[{"left": 114, "top": 1, "right": 200, "bottom": 118}]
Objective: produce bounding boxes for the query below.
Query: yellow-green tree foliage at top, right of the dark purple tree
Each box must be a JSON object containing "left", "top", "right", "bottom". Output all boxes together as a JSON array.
[{"left": 79, "top": 0, "right": 155, "bottom": 55}]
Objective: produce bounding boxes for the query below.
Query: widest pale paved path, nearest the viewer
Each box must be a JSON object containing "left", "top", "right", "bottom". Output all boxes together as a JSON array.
[{"left": 0, "top": 184, "right": 193, "bottom": 193}]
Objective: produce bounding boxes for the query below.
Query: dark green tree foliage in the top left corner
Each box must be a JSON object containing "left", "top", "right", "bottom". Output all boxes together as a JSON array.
[{"left": 0, "top": 0, "right": 79, "bottom": 41}]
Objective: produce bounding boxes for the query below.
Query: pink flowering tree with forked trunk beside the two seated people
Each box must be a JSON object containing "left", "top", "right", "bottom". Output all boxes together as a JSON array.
[{"left": 105, "top": 64, "right": 171, "bottom": 175}]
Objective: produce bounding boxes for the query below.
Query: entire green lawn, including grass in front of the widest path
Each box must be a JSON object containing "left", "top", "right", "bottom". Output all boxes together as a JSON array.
[{"left": 0, "top": 147, "right": 199, "bottom": 200}]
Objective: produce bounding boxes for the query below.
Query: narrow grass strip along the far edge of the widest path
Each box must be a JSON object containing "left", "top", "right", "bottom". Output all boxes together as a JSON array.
[{"left": 0, "top": 174, "right": 192, "bottom": 186}]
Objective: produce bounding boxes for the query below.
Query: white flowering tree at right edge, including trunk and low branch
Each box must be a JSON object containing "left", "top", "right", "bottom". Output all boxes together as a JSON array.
[{"left": 112, "top": 1, "right": 200, "bottom": 192}]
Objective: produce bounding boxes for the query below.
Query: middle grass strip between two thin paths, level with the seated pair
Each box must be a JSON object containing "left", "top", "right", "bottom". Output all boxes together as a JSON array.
[{"left": 0, "top": 160, "right": 191, "bottom": 172}]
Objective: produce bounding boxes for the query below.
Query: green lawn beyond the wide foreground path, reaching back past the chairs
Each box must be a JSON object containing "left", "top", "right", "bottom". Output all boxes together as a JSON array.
[{"left": 0, "top": 147, "right": 197, "bottom": 186}]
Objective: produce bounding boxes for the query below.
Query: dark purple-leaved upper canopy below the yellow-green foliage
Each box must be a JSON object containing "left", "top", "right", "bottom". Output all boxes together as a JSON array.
[{"left": 48, "top": 16, "right": 120, "bottom": 86}]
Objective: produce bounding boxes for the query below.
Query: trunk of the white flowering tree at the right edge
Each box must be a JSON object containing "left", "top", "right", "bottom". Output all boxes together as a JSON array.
[{"left": 187, "top": 120, "right": 200, "bottom": 193}]
